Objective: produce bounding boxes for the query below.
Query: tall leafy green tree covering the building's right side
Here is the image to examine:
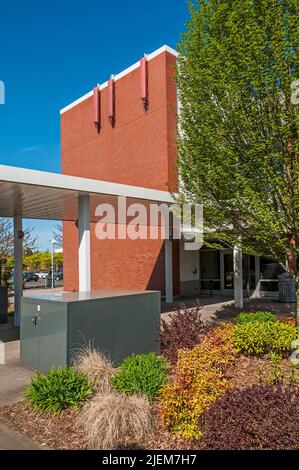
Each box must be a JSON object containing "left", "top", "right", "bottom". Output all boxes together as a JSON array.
[{"left": 177, "top": 0, "right": 299, "bottom": 318}]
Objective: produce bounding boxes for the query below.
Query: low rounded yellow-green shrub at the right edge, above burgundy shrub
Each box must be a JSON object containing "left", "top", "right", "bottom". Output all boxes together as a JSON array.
[{"left": 233, "top": 321, "right": 298, "bottom": 356}]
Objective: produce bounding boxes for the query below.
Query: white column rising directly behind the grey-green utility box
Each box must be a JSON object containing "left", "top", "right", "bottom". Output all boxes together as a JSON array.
[{"left": 78, "top": 196, "right": 91, "bottom": 292}]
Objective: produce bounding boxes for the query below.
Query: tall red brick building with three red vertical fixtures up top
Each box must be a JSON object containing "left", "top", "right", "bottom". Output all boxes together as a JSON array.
[{"left": 61, "top": 46, "right": 180, "bottom": 294}]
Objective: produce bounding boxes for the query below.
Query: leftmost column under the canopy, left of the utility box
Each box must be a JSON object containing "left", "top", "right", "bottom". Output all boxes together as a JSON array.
[{"left": 14, "top": 215, "right": 23, "bottom": 326}]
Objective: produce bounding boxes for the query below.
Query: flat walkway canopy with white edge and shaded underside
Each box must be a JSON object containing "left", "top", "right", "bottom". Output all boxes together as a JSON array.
[{"left": 0, "top": 165, "right": 174, "bottom": 221}]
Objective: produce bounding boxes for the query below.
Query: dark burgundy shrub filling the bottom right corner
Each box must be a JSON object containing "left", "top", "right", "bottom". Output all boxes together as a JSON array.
[{"left": 199, "top": 385, "right": 299, "bottom": 450}]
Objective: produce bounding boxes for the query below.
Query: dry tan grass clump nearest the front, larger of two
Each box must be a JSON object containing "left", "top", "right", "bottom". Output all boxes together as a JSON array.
[{"left": 77, "top": 394, "right": 153, "bottom": 449}]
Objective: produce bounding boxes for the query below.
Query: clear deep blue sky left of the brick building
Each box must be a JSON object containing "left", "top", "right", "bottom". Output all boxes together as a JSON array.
[{"left": 0, "top": 0, "right": 188, "bottom": 249}]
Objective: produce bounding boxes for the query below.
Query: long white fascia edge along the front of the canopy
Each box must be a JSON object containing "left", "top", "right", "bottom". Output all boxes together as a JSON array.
[{"left": 0, "top": 165, "right": 174, "bottom": 203}]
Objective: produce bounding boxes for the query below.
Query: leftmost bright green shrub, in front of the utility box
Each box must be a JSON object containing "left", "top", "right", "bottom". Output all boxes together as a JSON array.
[{"left": 25, "top": 367, "right": 92, "bottom": 415}]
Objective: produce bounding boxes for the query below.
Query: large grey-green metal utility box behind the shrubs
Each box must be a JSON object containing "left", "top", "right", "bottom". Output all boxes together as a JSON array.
[{"left": 21, "top": 291, "right": 161, "bottom": 372}]
